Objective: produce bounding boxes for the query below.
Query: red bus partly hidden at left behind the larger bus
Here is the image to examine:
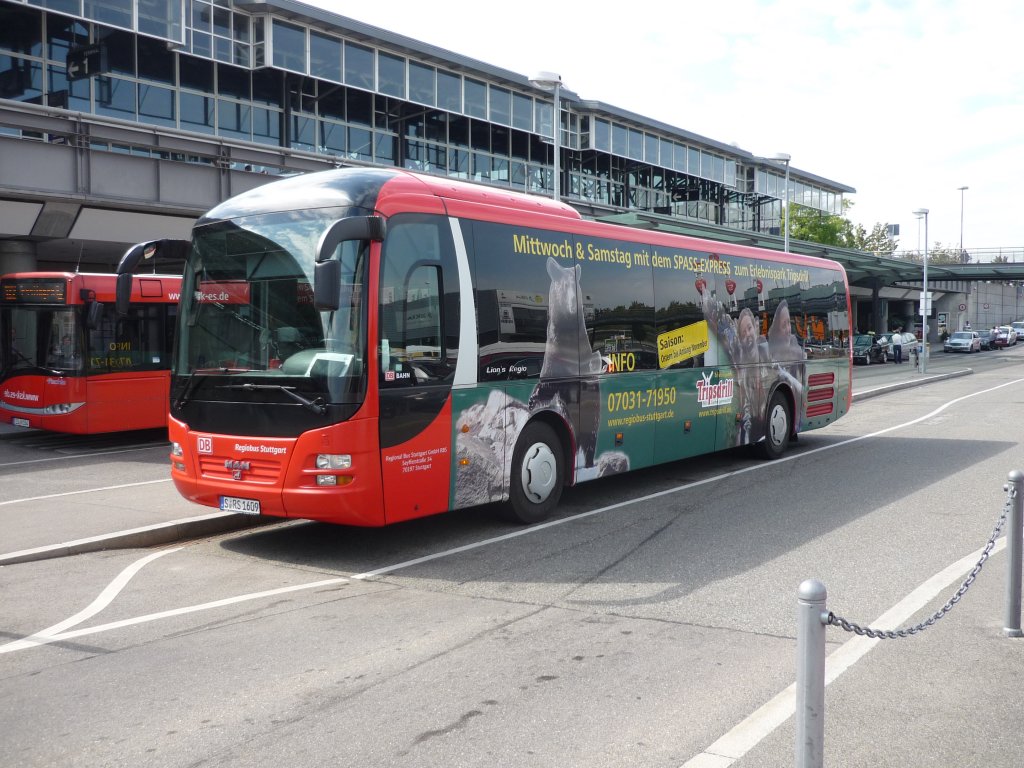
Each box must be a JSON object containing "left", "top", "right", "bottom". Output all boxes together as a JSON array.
[{"left": 0, "top": 272, "right": 181, "bottom": 434}]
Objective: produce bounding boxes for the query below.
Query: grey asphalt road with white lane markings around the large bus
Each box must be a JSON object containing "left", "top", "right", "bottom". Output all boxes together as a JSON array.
[{"left": 0, "top": 350, "right": 1024, "bottom": 768}]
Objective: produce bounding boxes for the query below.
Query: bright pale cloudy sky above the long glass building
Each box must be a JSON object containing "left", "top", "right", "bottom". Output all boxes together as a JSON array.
[{"left": 310, "top": 0, "right": 1024, "bottom": 261}]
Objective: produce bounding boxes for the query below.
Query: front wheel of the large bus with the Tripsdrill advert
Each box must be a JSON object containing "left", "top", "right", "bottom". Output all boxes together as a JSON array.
[{"left": 505, "top": 422, "right": 565, "bottom": 524}]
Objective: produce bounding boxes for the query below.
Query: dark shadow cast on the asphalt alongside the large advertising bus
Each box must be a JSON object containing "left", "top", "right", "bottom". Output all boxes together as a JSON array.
[{"left": 220, "top": 435, "right": 1017, "bottom": 599}]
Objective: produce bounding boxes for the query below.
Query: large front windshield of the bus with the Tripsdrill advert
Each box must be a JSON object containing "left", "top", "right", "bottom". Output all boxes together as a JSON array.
[{"left": 173, "top": 209, "right": 369, "bottom": 402}]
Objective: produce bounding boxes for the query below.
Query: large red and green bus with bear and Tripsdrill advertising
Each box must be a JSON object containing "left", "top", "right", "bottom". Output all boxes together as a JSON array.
[{"left": 163, "top": 168, "right": 852, "bottom": 526}]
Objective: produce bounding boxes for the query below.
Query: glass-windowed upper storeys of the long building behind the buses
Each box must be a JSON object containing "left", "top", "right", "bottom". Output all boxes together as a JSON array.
[{"left": 0, "top": 0, "right": 853, "bottom": 231}]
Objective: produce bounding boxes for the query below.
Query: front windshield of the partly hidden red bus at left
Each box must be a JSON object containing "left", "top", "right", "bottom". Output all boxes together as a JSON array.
[{"left": 0, "top": 306, "right": 84, "bottom": 377}]
